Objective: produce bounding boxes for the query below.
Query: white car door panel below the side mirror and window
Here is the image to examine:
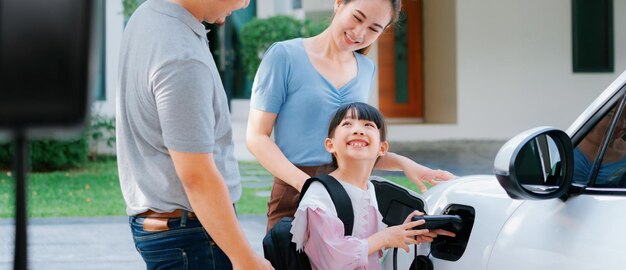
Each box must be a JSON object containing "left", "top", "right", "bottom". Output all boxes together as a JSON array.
[{"left": 486, "top": 195, "right": 626, "bottom": 270}]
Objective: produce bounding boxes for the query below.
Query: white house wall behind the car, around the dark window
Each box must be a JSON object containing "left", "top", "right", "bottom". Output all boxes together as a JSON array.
[{"left": 389, "top": 0, "right": 626, "bottom": 141}]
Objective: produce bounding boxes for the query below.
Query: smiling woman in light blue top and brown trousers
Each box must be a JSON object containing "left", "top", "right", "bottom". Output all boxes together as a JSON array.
[{"left": 246, "top": 0, "right": 454, "bottom": 229}]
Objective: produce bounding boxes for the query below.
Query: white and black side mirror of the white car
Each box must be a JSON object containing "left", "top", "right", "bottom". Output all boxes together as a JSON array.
[{"left": 494, "top": 127, "right": 574, "bottom": 200}]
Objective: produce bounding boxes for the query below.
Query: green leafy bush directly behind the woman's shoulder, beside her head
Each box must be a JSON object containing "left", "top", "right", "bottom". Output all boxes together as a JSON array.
[{"left": 241, "top": 15, "right": 328, "bottom": 79}]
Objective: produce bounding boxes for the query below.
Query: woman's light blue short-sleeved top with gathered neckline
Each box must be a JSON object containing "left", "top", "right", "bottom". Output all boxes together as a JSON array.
[{"left": 250, "top": 38, "right": 375, "bottom": 166}]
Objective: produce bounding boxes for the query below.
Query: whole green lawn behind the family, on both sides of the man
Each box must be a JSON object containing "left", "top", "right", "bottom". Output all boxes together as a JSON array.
[{"left": 0, "top": 159, "right": 418, "bottom": 218}]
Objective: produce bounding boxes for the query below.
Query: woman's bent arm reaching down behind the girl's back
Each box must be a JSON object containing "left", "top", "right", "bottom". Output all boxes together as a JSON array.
[{"left": 246, "top": 109, "right": 309, "bottom": 191}]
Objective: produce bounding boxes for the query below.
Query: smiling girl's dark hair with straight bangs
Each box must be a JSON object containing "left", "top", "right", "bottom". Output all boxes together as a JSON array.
[{"left": 328, "top": 102, "right": 387, "bottom": 169}]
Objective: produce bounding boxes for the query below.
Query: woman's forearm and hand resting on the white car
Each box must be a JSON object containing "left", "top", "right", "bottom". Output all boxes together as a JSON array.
[{"left": 374, "top": 152, "right": 456, "bottom": 192}]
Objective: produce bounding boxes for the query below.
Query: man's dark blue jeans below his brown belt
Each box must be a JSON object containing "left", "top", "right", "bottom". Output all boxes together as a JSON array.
[{"left": 129, "top": 216, "right": 233, "bottom": 270}]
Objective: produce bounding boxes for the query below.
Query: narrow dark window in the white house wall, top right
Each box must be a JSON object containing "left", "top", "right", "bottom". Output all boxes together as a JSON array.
[{"left": 572, "top": 0, "right": 613, "bottom": 72}]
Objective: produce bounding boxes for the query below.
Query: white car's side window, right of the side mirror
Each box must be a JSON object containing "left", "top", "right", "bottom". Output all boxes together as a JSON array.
[{"left": 573, "top": 97, "right": 626, "bottom": 188}]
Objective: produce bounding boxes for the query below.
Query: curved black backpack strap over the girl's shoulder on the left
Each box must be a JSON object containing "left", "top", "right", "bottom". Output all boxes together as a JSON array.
[{"left": 298, "top": 174, "right": 354, "bottom": 235}]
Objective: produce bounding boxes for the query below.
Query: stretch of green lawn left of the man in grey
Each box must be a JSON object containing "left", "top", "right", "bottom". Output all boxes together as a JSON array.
[{"left": 0, "top": 159, "right": 125, "bottom": 218}]
